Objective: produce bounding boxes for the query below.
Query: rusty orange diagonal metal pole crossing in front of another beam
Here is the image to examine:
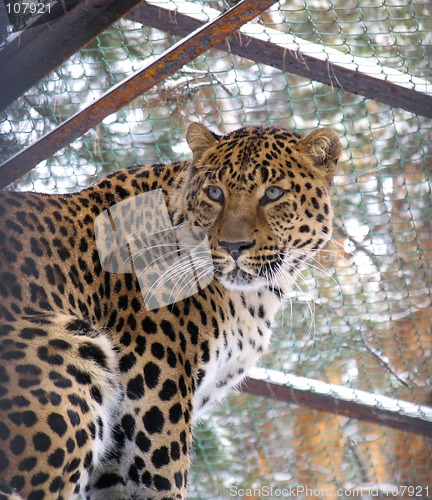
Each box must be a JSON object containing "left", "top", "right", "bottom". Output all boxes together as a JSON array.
[{"left": 0, "top": 0, "right": 277, "bottom": 188}]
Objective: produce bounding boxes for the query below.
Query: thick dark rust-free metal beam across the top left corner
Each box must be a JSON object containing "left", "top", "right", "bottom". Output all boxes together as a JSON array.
[{"left": 0, "top": 0, "right": 142, "bottom": 110}]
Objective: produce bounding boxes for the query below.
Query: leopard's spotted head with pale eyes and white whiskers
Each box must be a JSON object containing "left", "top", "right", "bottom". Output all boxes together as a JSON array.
[{"left": 176, "top": 123, "right": 341, "bottom": 291}]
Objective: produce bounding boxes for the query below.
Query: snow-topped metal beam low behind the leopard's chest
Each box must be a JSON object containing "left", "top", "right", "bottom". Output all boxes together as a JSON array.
[{"left": 240, "top": 369, "right": 432, "bottom": 437}]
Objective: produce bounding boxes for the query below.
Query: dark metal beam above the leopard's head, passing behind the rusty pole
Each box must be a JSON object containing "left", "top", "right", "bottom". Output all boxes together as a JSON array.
[{"left": 127, "top": 4, "right": 432, "bottom": 118}]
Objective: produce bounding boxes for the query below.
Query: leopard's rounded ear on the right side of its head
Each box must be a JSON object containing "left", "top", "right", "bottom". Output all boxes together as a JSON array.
[{"left": 298, "top": 127, "right": 342, "bottom": 182}]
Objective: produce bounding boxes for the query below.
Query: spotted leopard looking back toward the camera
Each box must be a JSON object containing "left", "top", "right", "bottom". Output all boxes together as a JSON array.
[{"left": 0, "top": 122, "right": 341, "bottom": 500}]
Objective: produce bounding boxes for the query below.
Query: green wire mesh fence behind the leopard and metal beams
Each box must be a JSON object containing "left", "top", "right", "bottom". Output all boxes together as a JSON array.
[{"left": 0, "top": 0, "right": 432, "bottom": 499}]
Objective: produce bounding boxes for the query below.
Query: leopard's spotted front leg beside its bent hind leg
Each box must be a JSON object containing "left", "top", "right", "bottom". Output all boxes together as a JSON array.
[{"left": 89, "top": 336, "right": 194, "bottom": 500}]
